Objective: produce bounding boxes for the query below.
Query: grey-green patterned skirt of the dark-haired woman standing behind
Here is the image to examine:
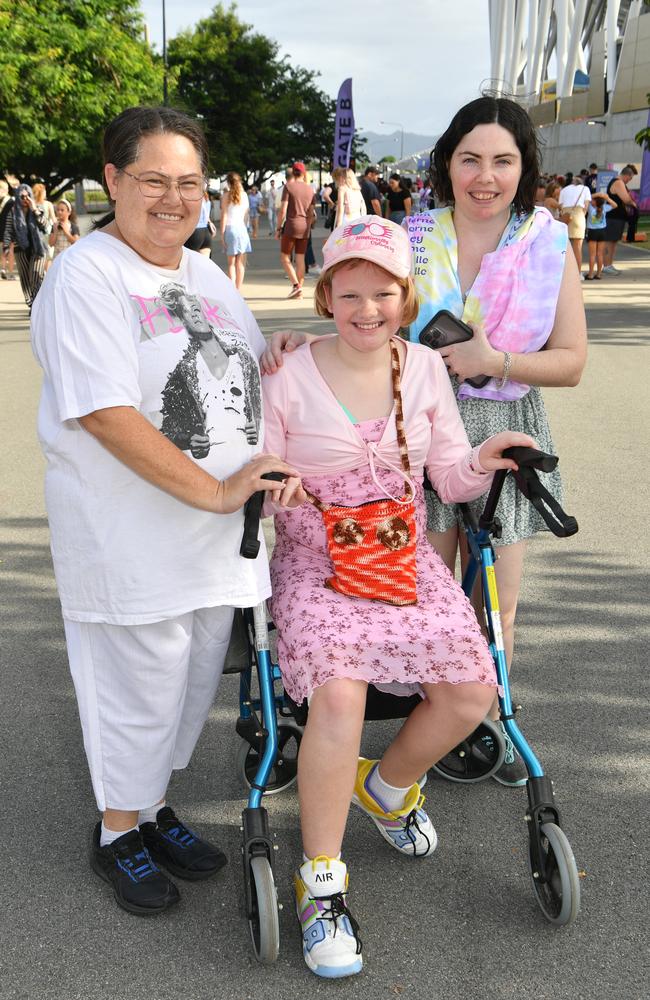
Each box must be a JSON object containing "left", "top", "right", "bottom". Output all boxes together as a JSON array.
[{"left": 426, "top": 386, "right": 562, "bottom": 547}]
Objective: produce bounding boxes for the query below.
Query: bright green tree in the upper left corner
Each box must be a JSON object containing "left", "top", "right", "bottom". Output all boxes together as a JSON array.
[{"left": 0, "top": 0, "right": 163, "bottom": 190}]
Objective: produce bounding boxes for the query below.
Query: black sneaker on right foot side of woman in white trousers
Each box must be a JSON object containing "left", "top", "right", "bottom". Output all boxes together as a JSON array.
[{"left": 140, "top": 806, "right": 227, "bottom": 881}]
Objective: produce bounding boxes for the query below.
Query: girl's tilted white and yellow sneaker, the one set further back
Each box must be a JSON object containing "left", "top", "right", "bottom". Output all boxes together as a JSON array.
[{"left": 352, "top": 757, "right": 438, "bottom": 858}]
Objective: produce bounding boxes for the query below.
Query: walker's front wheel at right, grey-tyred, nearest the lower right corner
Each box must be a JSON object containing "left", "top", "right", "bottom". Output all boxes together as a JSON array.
[{"left": 528, "top": 823, "right": 580, "bottom": 927}]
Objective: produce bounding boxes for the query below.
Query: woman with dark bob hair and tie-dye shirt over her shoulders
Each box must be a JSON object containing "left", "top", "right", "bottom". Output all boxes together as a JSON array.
[{"left": 405, "top": 97, "right": 586, "bottom": 785}]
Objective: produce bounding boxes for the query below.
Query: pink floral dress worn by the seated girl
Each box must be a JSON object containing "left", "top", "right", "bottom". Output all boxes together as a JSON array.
[{"left": 269, "top": 420, "right": 496, "bottom": 702}]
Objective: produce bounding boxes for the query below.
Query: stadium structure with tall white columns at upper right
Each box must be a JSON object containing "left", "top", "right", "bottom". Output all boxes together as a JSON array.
[{"left": 481, "top": 0, "right": 650, "bottom": 173}]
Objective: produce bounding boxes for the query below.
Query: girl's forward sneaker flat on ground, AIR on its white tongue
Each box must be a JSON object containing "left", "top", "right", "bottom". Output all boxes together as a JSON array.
[{"left": 293, "top": 855, "right": 363, "bottom": 979}]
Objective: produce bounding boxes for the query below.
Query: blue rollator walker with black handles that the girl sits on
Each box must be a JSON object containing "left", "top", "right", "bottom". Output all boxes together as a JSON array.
[{"left": 236, "top": 447, "right": 580, "bottom": 962}]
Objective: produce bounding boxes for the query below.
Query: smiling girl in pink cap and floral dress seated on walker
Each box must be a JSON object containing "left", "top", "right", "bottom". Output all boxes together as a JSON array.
[{"left": 263, "top": 215, "right": 533, "bottom": 978}]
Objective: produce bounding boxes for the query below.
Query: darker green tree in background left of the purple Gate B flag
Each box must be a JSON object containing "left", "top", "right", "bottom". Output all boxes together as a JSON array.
[{"left": 168, "top": 4, "right": 360, "bottom": 185}]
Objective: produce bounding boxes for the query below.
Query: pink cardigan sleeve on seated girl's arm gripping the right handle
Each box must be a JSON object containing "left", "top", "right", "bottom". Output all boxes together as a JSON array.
[{"left": 424, "top": 352, "right": 494, "bottom": 503}]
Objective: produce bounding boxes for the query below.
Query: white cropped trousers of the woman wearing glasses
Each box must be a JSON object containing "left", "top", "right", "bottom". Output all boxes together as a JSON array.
[{"left": 64, "top": 607, "right": 234, "bottom": 812}]
